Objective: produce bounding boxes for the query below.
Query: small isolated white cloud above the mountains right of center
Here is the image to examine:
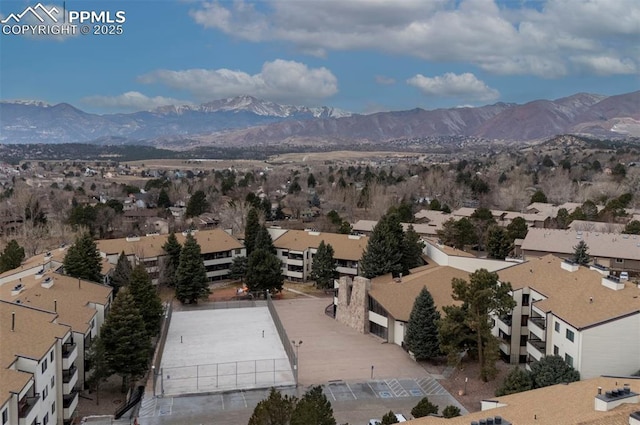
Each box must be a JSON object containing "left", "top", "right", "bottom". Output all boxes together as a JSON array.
[{"left": 407, "top": 72, "right": 500, "bottom": 101}]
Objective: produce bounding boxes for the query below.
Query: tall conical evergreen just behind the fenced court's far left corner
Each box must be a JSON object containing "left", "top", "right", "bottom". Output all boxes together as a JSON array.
[{"left": 176, "top": 233, "right": 210, "bottom": 303}]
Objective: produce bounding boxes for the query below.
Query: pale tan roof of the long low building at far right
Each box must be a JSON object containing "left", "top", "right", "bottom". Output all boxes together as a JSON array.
[{"left": 522, "top": 228, "right": 640, "bottom": 260}]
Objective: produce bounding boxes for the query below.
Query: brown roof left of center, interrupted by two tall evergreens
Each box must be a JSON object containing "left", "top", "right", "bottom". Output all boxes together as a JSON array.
[{"left": 96, "top": 229, "right": 244, "bottom": 258}]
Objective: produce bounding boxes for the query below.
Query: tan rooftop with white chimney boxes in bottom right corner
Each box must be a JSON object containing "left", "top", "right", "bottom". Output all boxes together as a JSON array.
[{"left": 407, "top": 376, "right": 640, "bottom": 425}]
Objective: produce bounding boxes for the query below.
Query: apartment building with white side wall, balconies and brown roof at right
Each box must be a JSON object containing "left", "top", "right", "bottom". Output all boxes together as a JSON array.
[{"left": 493, "top": 255, "right": 640, "bottom": 379}]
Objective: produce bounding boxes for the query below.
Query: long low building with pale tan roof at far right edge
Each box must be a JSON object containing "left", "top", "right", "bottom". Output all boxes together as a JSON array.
[{"left": 521, "top": 229, "right": 640, "bottom": 272}]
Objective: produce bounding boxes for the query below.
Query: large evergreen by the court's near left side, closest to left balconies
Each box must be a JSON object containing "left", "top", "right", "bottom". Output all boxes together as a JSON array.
[{"left": 100, "top": 289, "right": 151, "bottom": 392}]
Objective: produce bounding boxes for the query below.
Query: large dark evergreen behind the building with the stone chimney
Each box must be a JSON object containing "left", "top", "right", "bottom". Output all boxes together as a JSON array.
[{"left": 360, "top": 213, "right": 404, "bottom": 279}]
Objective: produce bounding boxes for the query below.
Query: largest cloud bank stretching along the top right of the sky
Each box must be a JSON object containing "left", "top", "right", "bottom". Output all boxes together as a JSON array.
[{"left": 191, "top": 0, "right": 640, "bottom": 78}]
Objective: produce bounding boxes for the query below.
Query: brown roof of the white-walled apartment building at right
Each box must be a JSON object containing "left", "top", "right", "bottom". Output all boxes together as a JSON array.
[{"left": 498, "top": 255, "right": 640, "bottom": 329}]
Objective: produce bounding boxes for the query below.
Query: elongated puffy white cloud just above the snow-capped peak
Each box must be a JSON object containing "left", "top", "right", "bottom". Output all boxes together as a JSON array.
[{"left": 138, "top": 59, "right": 338, "bottom": 103}]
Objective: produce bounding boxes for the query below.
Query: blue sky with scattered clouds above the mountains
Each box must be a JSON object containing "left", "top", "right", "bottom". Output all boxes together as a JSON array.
[{"left": 0, "top": 0, "right": 640, "bottom": 113}]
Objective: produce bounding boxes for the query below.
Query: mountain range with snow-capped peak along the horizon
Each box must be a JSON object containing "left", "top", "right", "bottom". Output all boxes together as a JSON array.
[{"left": 0, "top": 91, "right": 640, "bottom": 148}]
